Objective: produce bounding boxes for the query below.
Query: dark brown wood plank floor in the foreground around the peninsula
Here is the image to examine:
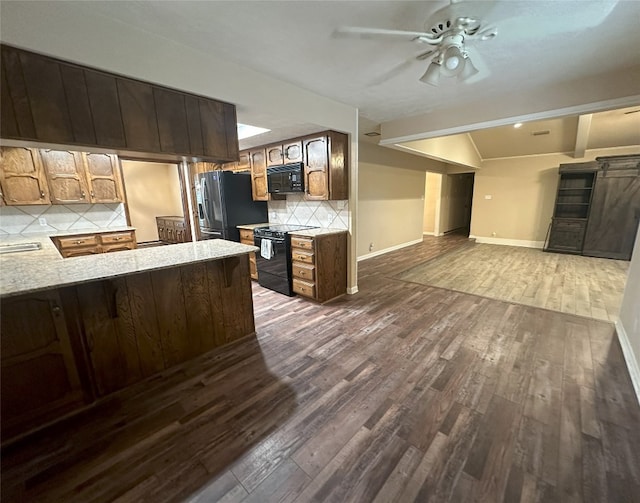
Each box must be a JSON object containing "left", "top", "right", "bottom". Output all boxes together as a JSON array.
[{"left": 2, "top": 237, "right": 640, "bottom": 503}]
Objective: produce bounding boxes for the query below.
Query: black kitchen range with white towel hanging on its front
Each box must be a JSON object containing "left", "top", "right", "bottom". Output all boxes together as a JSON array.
[{"left": 253, "top": 224, "right": 316, "bottom": 297}]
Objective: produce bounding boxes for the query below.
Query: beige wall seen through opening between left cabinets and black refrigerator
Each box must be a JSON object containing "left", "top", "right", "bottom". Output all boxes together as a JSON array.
[{"left": 121, "top": 161, "right": 184, "bottom": 243}]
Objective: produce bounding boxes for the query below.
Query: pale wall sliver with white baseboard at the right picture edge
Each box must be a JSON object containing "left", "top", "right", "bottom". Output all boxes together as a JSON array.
[{"left": 616, "top": 226, "right": 640, "bottom": 401}]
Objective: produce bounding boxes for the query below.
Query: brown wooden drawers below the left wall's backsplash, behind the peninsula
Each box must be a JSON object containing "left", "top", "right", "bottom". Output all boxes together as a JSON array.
[{"left": 51, "top": 230, "right": 136, "bottom": 258}]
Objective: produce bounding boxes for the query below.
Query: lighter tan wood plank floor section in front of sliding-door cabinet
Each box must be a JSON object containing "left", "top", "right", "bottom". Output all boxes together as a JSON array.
[{"left": 398, "top": 243, "right": 629, "bottom": 321}]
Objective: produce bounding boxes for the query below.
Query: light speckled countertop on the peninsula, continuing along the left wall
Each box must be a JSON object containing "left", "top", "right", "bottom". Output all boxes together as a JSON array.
[{"left": 0, "top": 229, "right": 258, "bottom": 297}]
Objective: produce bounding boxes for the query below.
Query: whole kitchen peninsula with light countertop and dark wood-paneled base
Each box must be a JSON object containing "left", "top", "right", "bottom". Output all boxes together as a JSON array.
[{"left": 0, "top": 236, "right": 256, "bottom": 443}]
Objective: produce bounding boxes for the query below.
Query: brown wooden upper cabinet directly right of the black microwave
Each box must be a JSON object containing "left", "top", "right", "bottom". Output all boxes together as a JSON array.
[{"left": 302, "top": 131, "right": 349, "bottom": 200}]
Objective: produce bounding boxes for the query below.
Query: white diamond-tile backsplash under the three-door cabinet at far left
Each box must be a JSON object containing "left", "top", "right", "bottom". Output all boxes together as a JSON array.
[{"left": 0, "top": 203, "right": 127, "bottom": 235}]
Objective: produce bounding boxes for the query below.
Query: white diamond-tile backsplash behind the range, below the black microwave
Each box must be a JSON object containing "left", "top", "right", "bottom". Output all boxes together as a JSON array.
[{"left": 268, "top": 194, "right": 349, "bottom": 229}]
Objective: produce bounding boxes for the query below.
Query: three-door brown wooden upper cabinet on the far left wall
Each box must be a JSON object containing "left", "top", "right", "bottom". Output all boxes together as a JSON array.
[{"left": 0, "top": 147, "right": 124, "bottom": 205}]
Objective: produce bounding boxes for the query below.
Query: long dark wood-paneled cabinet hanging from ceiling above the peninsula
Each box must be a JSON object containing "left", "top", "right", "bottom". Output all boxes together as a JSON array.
[{"left": 0, "top": 45, "right": 238, "bottom": 162}]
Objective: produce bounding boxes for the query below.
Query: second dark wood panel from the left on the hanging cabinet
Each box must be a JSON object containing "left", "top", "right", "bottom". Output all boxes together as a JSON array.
[{"left": 20, "top": 52, "right": 74, "bottom": 143}]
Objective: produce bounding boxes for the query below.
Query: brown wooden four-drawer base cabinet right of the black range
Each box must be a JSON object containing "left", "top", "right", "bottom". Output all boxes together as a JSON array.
[{"left": 291, "top": 231, "right": 347, "bottom": 302}]
